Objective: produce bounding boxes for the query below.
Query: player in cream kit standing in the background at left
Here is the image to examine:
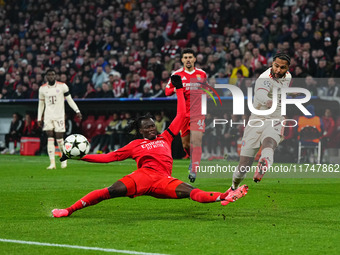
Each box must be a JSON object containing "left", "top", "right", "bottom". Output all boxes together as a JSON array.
[{"left": 38, "top": 69, "right": 82, "bottom": 169}]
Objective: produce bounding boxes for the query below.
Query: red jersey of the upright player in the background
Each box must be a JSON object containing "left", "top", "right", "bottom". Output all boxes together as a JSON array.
[{"left": 165, "top": 67, "right": 207, "bottom": 117}]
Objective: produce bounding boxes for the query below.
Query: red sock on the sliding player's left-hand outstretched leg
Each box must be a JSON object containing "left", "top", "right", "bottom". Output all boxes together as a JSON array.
[{"left": 66, "top": 188, "right": 110, "bottom": 215}]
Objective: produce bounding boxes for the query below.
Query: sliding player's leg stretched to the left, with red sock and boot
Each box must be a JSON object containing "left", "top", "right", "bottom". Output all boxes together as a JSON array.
[{"left": 52, "top": 180, "right": 127, "bottom": 218}]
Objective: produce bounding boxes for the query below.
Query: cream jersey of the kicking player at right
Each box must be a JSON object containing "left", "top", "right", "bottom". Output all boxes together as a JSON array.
[{"left": 251, "top": 68, "right": 292, "bottom": 119}]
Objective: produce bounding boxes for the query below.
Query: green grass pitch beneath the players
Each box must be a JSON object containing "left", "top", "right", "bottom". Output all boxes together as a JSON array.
[{"left": 0, "top": 155, "right": 340, "bottom": 254}]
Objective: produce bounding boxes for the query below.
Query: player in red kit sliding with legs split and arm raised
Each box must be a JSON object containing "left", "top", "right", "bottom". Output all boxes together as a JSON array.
[{"left": 52, "top": 75, "right": 248, "bottom": 218}]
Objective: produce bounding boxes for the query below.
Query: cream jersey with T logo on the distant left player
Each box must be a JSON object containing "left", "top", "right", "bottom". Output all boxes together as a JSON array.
[{"left": 39, "top": 81, "right": 69, "bottom": 120}]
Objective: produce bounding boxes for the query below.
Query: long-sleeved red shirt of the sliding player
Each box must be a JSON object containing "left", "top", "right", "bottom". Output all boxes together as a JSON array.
[{"left": 81, "top": 89, "right": 185, "bottom": 176}]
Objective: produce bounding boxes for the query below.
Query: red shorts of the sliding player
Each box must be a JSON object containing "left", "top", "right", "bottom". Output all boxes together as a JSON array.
[{"left": 119, "top": 168, "right": 183, "bottom": 198}]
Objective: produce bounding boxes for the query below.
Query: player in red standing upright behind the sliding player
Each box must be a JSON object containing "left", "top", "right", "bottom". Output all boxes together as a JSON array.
[{"left": 165, "top": 48, "right": 207, "bottom": 182}]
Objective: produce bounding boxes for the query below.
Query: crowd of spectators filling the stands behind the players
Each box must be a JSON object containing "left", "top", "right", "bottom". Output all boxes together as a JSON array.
[{"left": 0, "top": 0, "right": 340, "bottom": 161}]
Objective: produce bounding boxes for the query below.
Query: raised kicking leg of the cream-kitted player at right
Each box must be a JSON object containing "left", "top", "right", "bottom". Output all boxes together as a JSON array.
[{"left": 253, "top": 137, "right": 280, "bottom": 182}]
